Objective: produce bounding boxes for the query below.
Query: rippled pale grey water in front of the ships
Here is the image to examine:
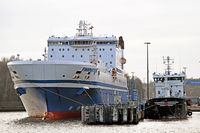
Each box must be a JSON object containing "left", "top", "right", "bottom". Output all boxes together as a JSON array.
[{"left": 0, "top": 112, "right": 200, "bottom": 133}]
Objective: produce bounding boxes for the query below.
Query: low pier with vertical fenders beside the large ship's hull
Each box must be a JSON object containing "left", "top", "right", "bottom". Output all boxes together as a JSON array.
[{"left": 81, "top": 105, "right": 142, "bottom": 124}]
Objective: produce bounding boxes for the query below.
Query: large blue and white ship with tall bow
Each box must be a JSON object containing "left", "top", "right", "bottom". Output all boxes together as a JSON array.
[{"left": 7, "top": 20, "right": 128, "bottom": 119}]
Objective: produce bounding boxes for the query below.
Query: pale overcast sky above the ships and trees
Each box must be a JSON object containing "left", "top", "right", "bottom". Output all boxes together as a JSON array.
[{"left": 0, "top": 0, "right": 200, "bottom": 81}]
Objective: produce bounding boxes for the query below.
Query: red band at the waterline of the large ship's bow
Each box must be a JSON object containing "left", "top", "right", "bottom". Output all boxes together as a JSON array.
[{"left": 44, "top": 111, "right": 81, "bottom": 120}]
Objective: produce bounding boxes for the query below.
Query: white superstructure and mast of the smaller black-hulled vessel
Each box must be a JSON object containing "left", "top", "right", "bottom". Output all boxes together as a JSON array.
[{"left": 153, "top": 56, "right": 186, "bottom": 98}]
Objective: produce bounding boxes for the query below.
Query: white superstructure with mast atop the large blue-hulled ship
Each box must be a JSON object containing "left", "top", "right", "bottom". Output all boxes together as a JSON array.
[{"left": 48, "top": 21, "right": 123, "bottom": 70}]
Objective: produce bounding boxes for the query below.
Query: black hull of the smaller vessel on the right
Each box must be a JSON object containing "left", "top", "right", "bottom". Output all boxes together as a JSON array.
[{"left": 145, "top": 97, "right": 188, "bottom": 119}]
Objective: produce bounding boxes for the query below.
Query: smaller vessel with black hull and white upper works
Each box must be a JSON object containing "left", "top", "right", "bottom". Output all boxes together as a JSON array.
[{"left": 145, "top": 56, "right": 191, "bottom": 119}]
